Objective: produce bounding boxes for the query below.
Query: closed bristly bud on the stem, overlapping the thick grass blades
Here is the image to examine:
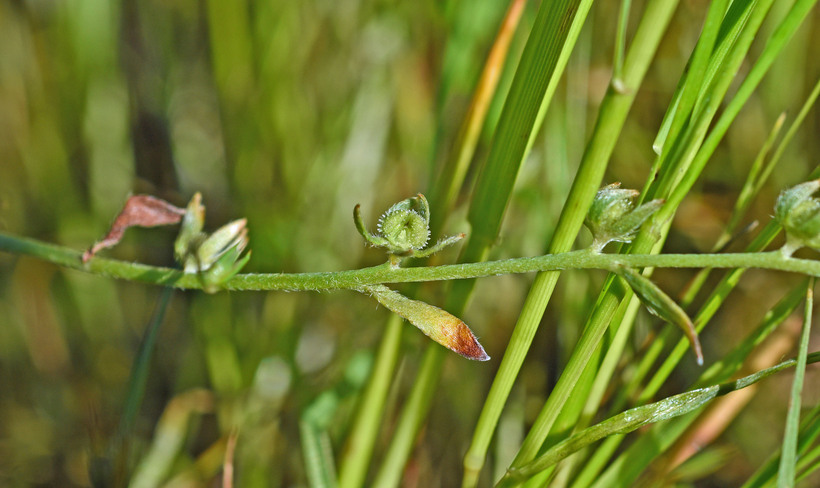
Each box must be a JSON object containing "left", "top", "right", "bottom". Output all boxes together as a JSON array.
[{"left": 584, "top": 183, "right": 663, "bottom": 252}]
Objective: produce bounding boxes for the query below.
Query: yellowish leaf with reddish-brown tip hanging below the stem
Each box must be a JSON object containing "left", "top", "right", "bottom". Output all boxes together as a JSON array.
[{"left": 359, "top": 285, "right": 490, "bottom": 361}]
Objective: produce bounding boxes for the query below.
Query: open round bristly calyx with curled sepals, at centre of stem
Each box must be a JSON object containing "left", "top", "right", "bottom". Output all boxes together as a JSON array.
[{"left": 353, "top": 193, "right": 464, "bottom": 265}]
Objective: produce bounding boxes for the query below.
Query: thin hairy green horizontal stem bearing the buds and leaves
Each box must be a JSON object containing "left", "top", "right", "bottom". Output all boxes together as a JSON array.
[{"left": 0, "top": 232, "right": 820, "bottom": 291}]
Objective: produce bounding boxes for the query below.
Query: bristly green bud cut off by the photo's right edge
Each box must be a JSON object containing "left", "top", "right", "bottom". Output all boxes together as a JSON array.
[{"left": 774, "top": 180, "right": 820, "bottom": 256}]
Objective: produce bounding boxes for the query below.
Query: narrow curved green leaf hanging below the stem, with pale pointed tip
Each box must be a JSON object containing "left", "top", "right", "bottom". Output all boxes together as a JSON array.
[{"left": 613, "top": 266, "right": 703, "bottom": 365}]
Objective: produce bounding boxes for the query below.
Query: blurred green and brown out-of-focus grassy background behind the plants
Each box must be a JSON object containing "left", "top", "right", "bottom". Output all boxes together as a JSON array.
[{"left": 0, "top": 0, "right": 820, "bottom": 486}]
